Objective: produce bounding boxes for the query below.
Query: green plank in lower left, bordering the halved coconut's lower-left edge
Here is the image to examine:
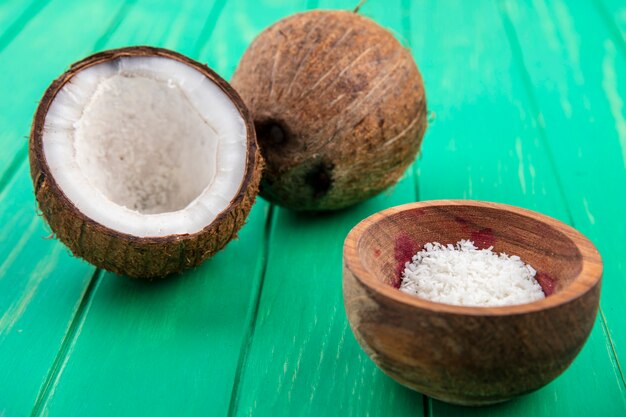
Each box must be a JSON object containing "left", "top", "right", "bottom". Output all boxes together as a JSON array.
[{"left": 0, "top": 170, "right": 93, "bottom": 416}]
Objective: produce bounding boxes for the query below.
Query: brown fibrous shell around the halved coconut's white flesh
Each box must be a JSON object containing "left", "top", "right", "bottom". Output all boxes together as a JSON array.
[{"left": 29, "top": 46, "right": 262, "bottom": 279}]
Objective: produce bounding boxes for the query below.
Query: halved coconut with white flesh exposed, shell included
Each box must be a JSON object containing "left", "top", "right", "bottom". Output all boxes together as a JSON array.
[{"left": 29, "top": 47, "right": 261, "bottom": 278}]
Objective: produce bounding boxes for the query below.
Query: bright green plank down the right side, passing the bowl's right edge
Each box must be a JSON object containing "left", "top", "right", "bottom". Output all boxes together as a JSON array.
[{"left": 507, "top": 1, "right": 626, "bottom": 376}]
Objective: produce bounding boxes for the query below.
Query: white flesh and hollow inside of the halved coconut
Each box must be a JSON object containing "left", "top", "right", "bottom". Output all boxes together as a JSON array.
[{"left": 42, "top": 57, "right": 247, "bottom": 237}]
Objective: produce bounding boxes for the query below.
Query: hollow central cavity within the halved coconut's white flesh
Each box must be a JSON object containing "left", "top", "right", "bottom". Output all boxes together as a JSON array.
[{"left": 74, "top": 74, "right": 219, "bottom": 214}]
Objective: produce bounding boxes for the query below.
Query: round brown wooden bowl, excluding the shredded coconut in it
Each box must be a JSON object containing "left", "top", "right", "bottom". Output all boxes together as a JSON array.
[{"left": 343, "top": 201, "right": 602, "bottom": 405}]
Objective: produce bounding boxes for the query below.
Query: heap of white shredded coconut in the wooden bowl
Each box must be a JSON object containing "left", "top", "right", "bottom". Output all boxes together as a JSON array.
[{"left": 400, "top": 240, "right": 545, "bottom": 306}]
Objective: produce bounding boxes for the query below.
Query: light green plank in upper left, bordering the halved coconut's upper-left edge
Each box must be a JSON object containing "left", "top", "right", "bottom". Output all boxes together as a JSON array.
[{"left": 0, "top": 0, "right": 129, "bottom": 180}]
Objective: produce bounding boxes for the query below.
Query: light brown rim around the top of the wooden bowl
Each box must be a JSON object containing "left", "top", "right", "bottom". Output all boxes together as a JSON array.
[{"left": 343, "top": 200, "right": 603, "bottom": 316}]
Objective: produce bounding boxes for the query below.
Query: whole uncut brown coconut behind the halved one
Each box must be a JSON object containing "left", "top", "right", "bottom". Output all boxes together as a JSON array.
[{"left": 232, "top": 11, "right": 427, "bottom": 210}]
